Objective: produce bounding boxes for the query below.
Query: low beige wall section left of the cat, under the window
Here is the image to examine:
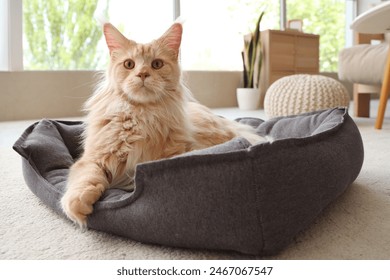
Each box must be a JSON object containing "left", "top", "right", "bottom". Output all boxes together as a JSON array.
[{"left": 0, "top": 71, "right": 94, "bottom": 121}]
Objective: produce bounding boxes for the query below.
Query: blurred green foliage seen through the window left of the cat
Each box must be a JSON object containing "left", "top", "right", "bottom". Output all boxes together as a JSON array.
[{"left": 23, "top": 0, "right": 108, "bottom": 70}]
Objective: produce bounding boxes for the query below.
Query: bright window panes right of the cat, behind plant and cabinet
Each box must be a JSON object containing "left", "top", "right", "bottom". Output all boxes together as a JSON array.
[{"left": 181, "top": 0, "right": 346, "bottom": 72}]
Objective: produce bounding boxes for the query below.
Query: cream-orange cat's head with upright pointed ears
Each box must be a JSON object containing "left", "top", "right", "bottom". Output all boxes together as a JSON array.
[{"left": 104, "top": 23, "right": 183, "bottom": 103}]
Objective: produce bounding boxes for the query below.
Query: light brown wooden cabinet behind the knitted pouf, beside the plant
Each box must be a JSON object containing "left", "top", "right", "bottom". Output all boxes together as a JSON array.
[{"left": 260, "top": 30, "right": 320, "bottom": 107}]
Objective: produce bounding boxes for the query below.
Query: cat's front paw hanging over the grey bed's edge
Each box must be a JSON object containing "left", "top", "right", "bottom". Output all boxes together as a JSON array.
[{"left": 61, "top": 185, "right": 102, "bottom": 228}]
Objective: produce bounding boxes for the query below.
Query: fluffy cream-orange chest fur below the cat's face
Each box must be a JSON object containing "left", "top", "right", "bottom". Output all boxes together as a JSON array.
[{"left": 86, "top": 103, "right": 192, "bottom": 169}]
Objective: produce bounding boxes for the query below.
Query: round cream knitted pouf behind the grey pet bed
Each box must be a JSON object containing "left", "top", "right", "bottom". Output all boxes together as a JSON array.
[{"left": 264, "top": 74, "right": 349, "bottom": 118}]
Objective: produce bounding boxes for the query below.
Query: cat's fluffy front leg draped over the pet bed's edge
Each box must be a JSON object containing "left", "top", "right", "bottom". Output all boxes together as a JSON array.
[{"left": 61, "top": 158, "right": 109, "bottom": 227}]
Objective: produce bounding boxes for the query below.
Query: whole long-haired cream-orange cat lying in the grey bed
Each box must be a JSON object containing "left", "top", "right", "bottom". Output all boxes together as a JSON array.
[{"left": 61, "top": 23, "right": 266, "bottom": 227}]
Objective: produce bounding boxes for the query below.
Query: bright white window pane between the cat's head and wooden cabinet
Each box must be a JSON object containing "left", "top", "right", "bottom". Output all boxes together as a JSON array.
[{"left": 180, "top": 0, "right": 279, "bottom": 70}]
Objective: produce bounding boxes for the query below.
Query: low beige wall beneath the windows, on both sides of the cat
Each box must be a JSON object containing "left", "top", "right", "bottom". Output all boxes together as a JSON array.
[{"left": 0, "top": 71, "right": 241, "bottom": 121}]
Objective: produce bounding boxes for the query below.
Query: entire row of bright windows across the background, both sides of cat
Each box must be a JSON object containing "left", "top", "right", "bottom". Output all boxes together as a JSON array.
[{"left": 0, "top": 0, "right": 353, "bottom": 71}]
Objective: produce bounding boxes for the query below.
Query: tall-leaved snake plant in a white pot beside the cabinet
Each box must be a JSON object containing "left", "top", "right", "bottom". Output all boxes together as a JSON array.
[{"left": 237, "top": 12, "right": 264, "bottom": 110}]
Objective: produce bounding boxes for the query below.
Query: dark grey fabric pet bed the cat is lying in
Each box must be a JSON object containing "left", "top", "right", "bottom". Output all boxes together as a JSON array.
[{"left": 14, "top": 109, "right": 363, "bottom": 255}]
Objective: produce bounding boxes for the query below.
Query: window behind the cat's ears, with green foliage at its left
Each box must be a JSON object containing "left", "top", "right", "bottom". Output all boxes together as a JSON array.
[{"left": 23, "top": 0, "right": 173, "bottom": 70}]
